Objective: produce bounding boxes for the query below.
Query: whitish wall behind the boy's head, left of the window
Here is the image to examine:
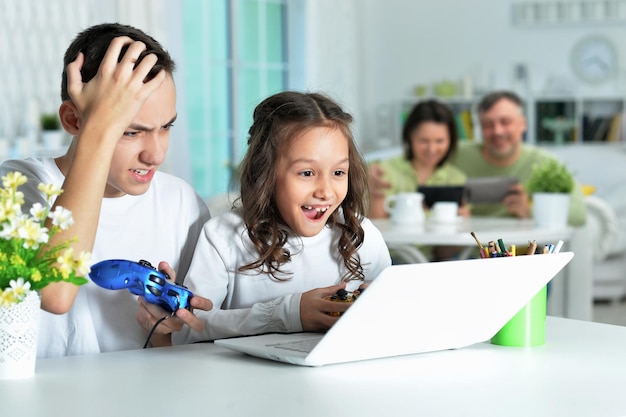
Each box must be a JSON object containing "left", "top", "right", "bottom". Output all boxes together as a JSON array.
[{"left": 0, "top": 0, "right": 184, "bottom": 174}]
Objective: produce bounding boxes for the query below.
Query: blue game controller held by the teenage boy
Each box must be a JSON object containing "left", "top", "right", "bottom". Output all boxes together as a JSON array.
[{"left": 89, "top": 259, "right": 193, "bottom": 313}]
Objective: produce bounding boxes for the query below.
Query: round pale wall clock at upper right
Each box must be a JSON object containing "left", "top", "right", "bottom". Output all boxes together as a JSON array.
[{"left": 571, "top": 35, "right": 618, "bottom": 83}]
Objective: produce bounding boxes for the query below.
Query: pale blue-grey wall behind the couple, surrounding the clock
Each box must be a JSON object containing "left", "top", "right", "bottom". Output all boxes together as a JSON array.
[{"left": 358, "top": 0, "right": 626, "bottom": 148}]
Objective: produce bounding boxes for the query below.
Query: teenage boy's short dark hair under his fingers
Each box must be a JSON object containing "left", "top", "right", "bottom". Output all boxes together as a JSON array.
[{"left": 61, "top": 23, "right": 176, "bottom": 101}]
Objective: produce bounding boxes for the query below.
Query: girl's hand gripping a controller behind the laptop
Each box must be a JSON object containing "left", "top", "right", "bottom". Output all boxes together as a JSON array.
[{"left": 300, "top": 282, "right": 350, "bottom": 331}]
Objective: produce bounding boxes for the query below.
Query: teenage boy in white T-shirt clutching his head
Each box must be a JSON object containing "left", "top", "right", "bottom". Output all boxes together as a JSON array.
[{"left": 0, "top": 24, "right": 211, "bottom": 357}]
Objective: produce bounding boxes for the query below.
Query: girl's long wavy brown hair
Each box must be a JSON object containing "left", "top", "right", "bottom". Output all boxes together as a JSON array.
[{"left": 239, "top": 91, "right": 369, "bottom": 280}]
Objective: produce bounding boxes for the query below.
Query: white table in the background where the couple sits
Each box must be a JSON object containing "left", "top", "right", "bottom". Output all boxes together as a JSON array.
[{"left": 373, "top": 217, "right": 593, "bottom": 320}]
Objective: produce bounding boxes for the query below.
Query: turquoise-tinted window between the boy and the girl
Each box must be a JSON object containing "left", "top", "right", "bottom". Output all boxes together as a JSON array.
[{"left": 182, "top": 0, "right": 289, "bottom": 198}]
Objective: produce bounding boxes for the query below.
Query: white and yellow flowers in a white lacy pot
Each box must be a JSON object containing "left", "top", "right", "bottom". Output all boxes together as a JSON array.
[{"left": 0, "top": 172, "right": 91, "bottom": 378}]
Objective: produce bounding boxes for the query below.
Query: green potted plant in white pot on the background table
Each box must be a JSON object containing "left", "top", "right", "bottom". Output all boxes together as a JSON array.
[{"left": 526, "top": 159, "right": 575, "bottom": 227}]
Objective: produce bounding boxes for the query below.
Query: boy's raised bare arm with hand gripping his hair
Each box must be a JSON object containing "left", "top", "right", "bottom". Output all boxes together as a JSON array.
[{"left": 41, "top": 37, "right": 166, "bottom": 314}]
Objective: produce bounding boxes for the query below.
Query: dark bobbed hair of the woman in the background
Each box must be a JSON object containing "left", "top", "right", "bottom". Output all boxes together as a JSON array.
[{"left": 402, "top": 100, "right": 459, "bottom": 166}]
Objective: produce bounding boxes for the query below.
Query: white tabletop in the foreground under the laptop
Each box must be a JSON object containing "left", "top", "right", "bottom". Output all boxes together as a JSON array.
[{"left": 0, "top": 317, "right": 626, "bottom": 417}]
